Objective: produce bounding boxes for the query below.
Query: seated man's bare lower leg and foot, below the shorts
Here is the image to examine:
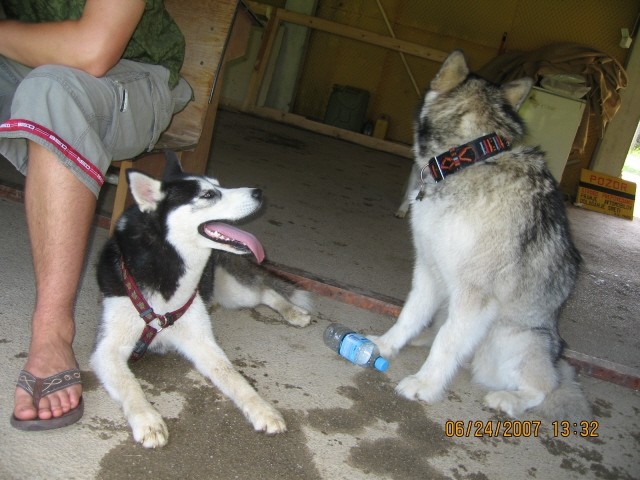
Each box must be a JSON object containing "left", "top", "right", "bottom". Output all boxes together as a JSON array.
[{"left": 14, "top": 142, "right": 96, "bottom": 420}]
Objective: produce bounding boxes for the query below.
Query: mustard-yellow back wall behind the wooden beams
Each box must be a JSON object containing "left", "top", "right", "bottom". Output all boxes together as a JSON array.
[{"left": 294, "top": 0, "right": 640, "bottom": 143}]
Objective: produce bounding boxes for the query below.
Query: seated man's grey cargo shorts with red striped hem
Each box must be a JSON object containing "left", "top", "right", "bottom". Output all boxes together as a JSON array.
[{"left": 0, "top": 56, "right": 192, "bottom": 196}]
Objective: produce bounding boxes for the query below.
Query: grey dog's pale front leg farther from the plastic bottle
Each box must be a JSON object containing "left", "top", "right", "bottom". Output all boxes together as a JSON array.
[{"left": 396, "top": 293, "right": 498, "bottom": 403}]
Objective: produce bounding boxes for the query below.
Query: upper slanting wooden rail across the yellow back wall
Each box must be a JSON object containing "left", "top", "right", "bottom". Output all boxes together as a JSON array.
[{"left": 278, "top": 10, "right": 449, "bottom": 62}]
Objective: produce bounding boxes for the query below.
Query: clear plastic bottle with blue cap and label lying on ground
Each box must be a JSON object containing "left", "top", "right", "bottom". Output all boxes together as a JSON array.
[{"left": 324, "top": 323, "right": 389, "bottom": 372}]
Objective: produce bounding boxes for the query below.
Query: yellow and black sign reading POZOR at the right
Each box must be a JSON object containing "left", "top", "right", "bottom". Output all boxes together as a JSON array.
[{"left": 576, "top": 168, "right": 636, "bottom": 220}]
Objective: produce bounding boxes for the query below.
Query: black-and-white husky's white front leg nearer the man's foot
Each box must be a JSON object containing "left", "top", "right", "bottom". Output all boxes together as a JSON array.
[{"left": 91, "top": 320, "right": 169, "bottom": 448}]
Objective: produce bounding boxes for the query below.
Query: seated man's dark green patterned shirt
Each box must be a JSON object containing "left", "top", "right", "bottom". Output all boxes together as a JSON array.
[{"left": 0, "top": 0, "right": 185, "bottom": 88}]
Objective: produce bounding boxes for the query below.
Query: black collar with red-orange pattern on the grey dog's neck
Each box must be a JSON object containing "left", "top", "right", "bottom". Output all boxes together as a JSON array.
[{"left": 416, "top": 133, "right": 511, "bottom": 200}]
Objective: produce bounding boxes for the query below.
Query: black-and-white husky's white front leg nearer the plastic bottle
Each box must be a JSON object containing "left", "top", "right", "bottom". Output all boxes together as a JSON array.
[{"left": 171, "top": 304, "right": 287, "bottom": 434}]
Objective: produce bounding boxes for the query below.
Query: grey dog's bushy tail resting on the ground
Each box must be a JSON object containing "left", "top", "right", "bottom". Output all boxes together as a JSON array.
[{"left": 535, "top": 359, "right": 593, "bottom": 423}]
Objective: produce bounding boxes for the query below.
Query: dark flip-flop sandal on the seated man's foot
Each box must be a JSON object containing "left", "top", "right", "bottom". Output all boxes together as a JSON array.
[{"left": 11, "top": 368, "right": 84, "bottom": 432}]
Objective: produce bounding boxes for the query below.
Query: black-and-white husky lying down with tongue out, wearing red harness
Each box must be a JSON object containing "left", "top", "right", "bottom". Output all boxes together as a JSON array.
[{"left": 91, "top": 156, "right": 310, "bottom": 447}]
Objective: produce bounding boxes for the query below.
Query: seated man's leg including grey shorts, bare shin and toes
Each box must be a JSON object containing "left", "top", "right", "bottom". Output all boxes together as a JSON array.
[{"left": 0, "top": 61, "right": 191, "bottom": 420}]
